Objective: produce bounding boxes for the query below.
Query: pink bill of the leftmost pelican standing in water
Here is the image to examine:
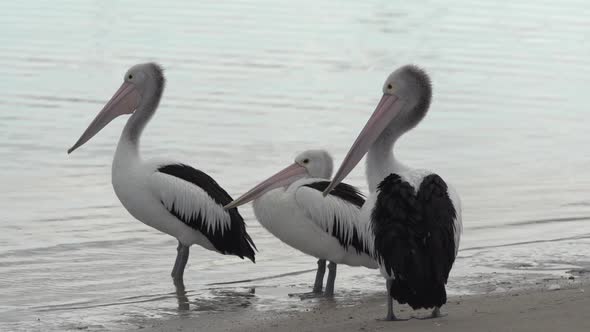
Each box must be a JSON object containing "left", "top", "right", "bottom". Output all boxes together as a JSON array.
[{"left": 68, "top": 82, "right": 140, "bottom": 154}]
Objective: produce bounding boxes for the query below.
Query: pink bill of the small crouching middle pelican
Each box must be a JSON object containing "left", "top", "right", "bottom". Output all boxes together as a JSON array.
[{"left": 223, "top": 163, "right": 307, "bottom": 210}]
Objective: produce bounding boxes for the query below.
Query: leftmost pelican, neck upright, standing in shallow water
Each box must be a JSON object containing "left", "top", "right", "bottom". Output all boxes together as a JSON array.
[{"left": 68, "top": 63, "right": 256, "bottom": 283}]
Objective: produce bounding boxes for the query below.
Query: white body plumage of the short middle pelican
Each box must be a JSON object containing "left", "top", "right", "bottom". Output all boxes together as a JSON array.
[{"left": 253, "top": 178, "right": 377, "bottom": 268}]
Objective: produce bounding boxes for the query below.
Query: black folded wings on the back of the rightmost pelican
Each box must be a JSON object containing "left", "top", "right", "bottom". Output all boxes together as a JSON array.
[{"left": 371, "top": 174, "right": 456, "bottom": 309}]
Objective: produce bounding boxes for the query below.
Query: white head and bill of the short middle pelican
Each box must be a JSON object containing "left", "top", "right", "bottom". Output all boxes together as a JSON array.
[{"left": 224, "top": 150, "right": 333, "bottom": 209}]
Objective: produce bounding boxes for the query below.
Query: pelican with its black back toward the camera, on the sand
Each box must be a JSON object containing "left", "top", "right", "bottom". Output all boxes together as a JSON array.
[{"left": 324, "top": 65, "right": 462, "bottom": 320}]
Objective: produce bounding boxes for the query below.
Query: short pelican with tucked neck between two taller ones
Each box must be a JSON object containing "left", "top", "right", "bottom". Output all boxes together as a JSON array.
[{"left": 226, "top": 150, "right": 378, "bottom": 297}]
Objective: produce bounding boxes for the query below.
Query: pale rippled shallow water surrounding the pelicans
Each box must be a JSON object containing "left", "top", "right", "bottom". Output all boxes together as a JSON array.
[{"left": 0, "top": 0, "right": 590, "bottom": 331}]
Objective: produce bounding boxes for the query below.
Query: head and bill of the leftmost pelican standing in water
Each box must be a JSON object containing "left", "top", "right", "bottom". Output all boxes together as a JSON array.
[{"left": 68, "top": 63, "right": 164, "bottom": 153}]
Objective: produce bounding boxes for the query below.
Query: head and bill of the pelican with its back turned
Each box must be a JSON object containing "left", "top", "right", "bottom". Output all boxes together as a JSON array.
[{"left": 324, "top": 65, "right": 432, "bottom": 196}]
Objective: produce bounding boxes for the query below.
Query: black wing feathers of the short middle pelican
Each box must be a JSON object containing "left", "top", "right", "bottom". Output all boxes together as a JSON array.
[{"left": 304, "top": 181, "right": 373, "bottom": 256}]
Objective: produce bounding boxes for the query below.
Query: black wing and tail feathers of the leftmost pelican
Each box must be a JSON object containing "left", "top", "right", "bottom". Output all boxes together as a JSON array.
[{"left": 158, "top": 164, "right": 256, "bottom": 262}]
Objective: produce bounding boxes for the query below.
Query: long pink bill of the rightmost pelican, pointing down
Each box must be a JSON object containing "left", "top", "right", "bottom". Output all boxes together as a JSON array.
[{"left": 323, "top": 94, "right": 403, "bottom": 196}]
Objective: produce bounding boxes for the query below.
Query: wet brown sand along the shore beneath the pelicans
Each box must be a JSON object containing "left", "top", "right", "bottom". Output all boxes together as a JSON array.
[{"left": 142, "top": 282, "right": 590, "bottom": 332}]
